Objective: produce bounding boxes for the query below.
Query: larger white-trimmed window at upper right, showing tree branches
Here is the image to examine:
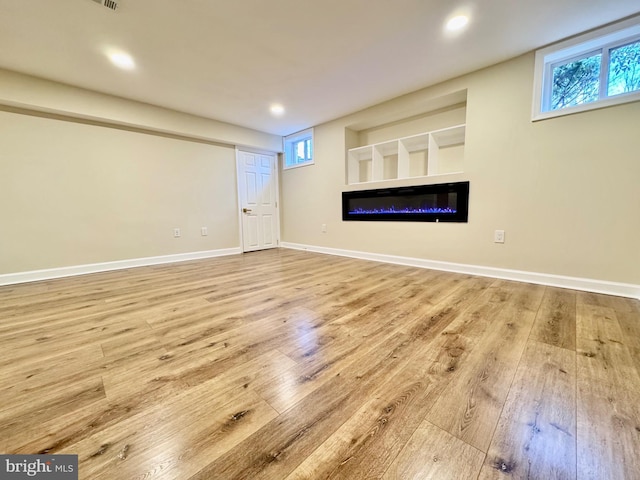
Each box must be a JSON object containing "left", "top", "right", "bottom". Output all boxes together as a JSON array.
[{"left": 533, "top": 17, "right": 640, "bottom": 120}]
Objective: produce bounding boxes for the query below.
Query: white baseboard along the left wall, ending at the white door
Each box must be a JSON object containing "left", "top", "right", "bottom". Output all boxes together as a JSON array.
[{"left": 0, "top": 247, "right": 242, "bottom": 285}]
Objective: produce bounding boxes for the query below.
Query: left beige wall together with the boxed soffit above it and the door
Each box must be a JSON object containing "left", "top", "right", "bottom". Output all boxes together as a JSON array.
[{"left": 0, "top": 69, "right": 282, "bottom": 275}]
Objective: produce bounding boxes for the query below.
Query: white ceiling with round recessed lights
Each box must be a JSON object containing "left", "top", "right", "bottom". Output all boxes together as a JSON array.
[{"left": 0, "top": 0, "right": 640, "bottom": 135}]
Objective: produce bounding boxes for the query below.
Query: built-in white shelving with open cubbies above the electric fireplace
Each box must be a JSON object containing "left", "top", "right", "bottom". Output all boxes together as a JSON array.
[{"left": 347, "top": 125, "right": 466, "bottom": 184}]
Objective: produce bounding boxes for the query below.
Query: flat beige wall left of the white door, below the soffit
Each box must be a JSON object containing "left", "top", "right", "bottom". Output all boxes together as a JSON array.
[{"left": 0, "top": 111, "right": 240, "bottom": 274}]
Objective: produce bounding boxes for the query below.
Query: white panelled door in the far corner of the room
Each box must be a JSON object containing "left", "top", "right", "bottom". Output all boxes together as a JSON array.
[{"left": 237, "top": 150, "right": 279, "bottom": 252}]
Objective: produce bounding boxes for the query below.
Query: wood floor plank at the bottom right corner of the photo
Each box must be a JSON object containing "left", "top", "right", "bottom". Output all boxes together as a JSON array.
[{"left": 577, "top": 302, "right": 640, "bottom": 480}]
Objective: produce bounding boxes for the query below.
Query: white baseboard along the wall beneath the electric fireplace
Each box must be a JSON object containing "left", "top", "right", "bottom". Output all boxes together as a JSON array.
[{"left": 280, "top": 242, "right": 640, "bottom": 300}]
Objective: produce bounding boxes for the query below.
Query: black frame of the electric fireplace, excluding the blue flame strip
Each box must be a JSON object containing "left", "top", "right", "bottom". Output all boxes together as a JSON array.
[{"left": 342, "top": 182, "right": 469, "bottom": 223}]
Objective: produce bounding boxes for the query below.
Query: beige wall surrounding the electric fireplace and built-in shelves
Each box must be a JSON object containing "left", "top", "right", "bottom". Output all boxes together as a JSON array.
[{"left": 282, "top": 54, "right": 640, "bottom": 284}]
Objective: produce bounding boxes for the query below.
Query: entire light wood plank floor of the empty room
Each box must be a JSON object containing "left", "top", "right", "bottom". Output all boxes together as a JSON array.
[{"left": 0, "top": 250, "right": 640, "bottom": 480}]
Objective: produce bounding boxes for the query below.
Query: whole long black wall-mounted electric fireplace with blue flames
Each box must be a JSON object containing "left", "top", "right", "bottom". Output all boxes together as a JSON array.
[{"left": 342, "top": 182, "right": 469, "bottom": 223}]
